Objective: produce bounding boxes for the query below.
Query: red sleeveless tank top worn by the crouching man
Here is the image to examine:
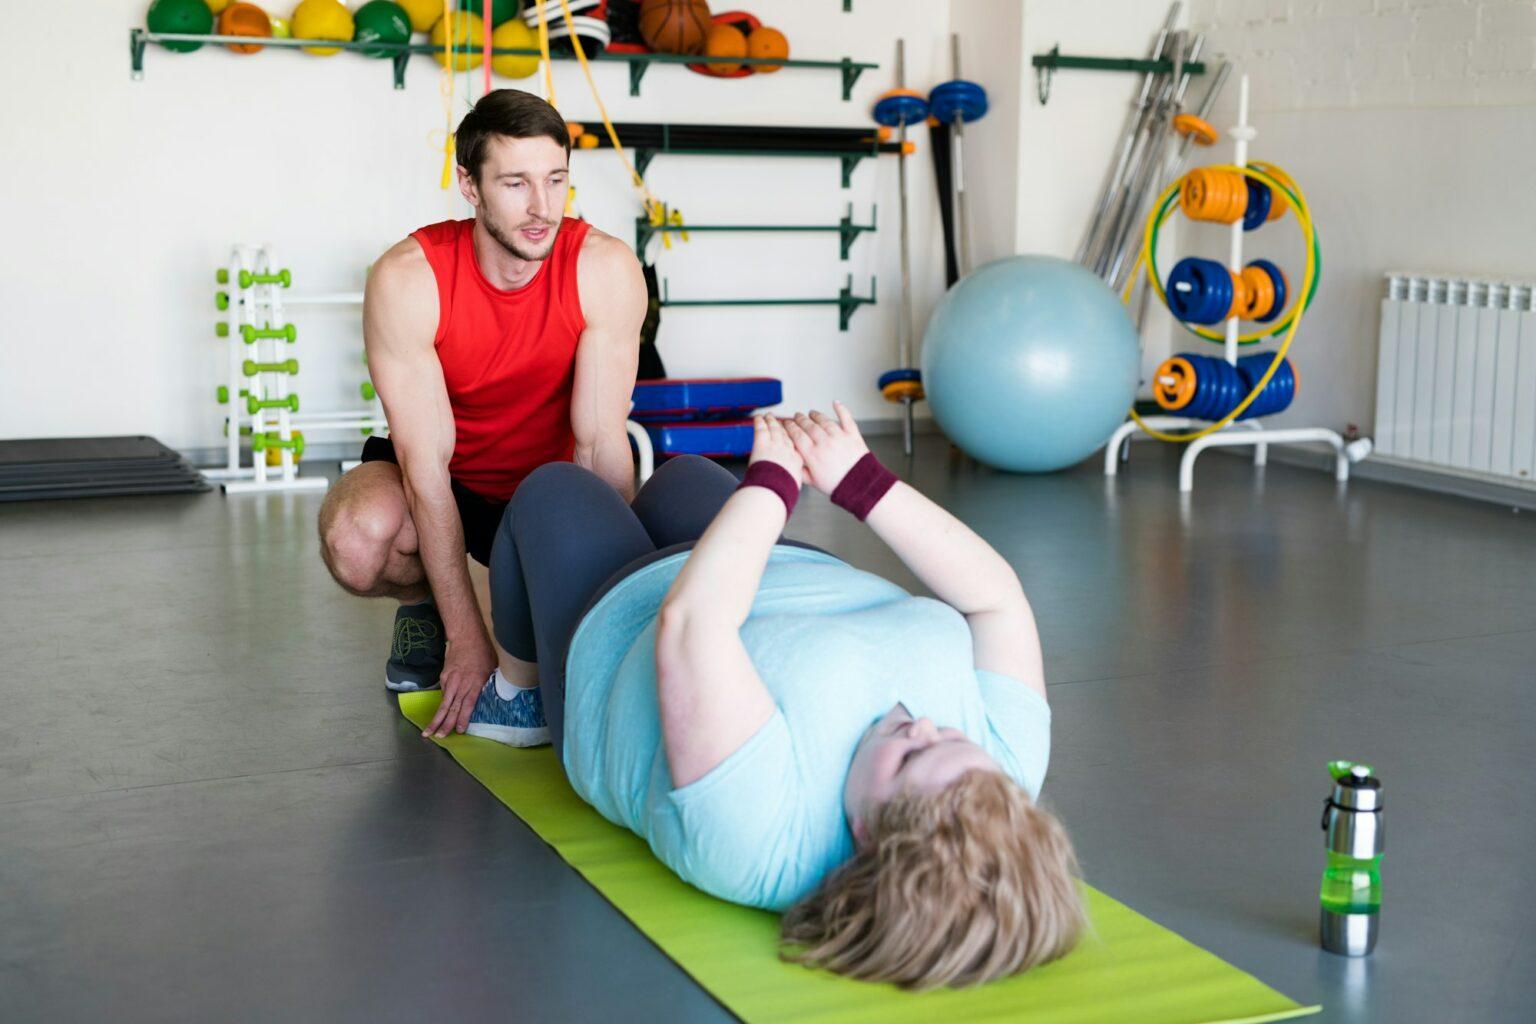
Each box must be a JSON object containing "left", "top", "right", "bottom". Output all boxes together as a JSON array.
[{"left": 412, "top": 216, "right": 588, "bottom": 500}]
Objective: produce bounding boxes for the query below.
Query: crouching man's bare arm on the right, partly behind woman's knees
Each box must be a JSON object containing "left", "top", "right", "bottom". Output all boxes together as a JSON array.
[{"left": 571, "top": 230, "right": 647, "bottom": 500}]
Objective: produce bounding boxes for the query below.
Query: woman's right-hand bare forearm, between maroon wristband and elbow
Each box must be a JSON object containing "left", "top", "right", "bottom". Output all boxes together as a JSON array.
[{"left": 865, "top": 484, "right": 1021, "bottom": 614}]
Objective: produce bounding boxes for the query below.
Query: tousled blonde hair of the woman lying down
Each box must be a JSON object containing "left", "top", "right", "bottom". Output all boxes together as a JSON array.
[{"left": 780, "top": 771, "right": 1084, "bottom": 990}]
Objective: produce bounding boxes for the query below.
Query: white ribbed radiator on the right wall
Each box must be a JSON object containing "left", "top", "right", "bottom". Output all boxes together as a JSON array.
[{"left": 1376, "top": 272, "right": 1536, "bottom": 482}]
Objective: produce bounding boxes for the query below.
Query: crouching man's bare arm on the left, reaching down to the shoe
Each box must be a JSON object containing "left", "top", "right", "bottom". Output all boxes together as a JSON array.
[{"left": 362, "top": 239, "right": 496, "bottom": 731}]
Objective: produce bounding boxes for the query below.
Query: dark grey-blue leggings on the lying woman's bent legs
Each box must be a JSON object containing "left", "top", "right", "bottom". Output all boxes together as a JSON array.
[{"left": 490, "top": 454, "right": 811, "bottom": 754}]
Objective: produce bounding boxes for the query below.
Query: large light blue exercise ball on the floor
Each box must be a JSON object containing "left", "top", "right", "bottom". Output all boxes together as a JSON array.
[{"left": 923, "top": 256, "right": 1141, "bottom": 473}]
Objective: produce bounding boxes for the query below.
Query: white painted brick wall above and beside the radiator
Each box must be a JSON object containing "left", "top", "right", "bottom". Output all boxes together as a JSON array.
[{"left": 1184, "top": 0, "right": 1536, "bottom": 433}]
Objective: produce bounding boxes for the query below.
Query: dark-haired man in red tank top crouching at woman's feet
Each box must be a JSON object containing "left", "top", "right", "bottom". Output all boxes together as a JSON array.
[{"left": 319, "top": 89, "right": 647, "bottom": 745}]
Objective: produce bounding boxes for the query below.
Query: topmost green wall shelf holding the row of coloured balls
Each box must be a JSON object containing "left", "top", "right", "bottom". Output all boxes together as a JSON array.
[{"left": 129, "top": 29, "right": 880, "bottom": 100}]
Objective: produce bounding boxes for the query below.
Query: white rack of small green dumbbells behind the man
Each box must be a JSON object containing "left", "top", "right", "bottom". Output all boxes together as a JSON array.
[{"left": 204, "top": 244, "right": 389, "bottom": 494}]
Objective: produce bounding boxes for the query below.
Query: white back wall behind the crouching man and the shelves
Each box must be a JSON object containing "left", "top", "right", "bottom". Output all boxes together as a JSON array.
[{"left": 0, "top": 0, "right": 949, "bottom": 448}]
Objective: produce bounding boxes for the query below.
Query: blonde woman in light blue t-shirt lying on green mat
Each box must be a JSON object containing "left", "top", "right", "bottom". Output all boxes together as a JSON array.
[{"left": 470, "top": 405, "right": 1083, "bottom": 989}]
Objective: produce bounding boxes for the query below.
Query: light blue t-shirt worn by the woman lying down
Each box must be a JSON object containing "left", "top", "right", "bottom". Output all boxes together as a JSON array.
[{"left": 565, "top": 545, "right": 1051, "bottom": 910}]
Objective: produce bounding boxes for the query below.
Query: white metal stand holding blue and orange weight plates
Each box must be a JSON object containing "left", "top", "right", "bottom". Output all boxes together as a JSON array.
[{"left": 1104, "top": 75, "right": 1372, "bottom": 494}]
